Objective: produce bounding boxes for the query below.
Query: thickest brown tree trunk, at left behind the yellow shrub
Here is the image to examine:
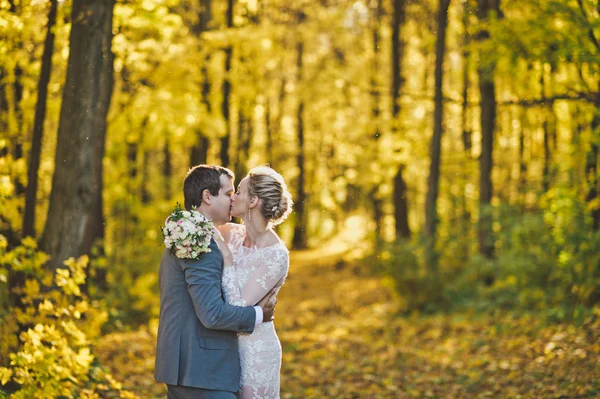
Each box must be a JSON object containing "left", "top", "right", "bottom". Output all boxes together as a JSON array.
[{"left": 40, "top": 0, "right": 114, "bottom": 276}]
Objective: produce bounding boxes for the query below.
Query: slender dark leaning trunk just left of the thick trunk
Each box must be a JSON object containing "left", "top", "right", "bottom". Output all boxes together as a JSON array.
[{"left": 22, "top": 0, "right": 58, "bottom": 237}]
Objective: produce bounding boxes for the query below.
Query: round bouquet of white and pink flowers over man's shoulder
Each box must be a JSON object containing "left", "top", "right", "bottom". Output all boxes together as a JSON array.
[{"left": 161, "top": 203, "right": 214, "bottom": 259}]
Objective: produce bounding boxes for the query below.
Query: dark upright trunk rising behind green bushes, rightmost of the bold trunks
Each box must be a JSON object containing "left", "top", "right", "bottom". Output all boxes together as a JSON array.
[{"left": 477, "top": 0, "right": 499, "bottom": 258}]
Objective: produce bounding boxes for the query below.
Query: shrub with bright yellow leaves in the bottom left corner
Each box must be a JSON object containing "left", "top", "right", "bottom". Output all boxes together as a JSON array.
[{"left": 0, "top": 236, "right": 135, "bottom": 399}]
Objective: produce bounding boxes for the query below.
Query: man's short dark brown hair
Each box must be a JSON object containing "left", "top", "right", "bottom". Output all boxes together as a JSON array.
[{"left": 183, "top": 165, "right": 234, "bottom": 210}]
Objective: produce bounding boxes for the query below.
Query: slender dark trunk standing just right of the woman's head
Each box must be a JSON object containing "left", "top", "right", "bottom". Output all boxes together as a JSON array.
[{"left": 292, "top": 12, "right": 308, "bottom": 249}]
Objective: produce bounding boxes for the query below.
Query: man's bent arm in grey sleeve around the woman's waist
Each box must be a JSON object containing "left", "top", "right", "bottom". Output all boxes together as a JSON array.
[{"left": 183, "top": 242, "right": 262, "bottom": 333}]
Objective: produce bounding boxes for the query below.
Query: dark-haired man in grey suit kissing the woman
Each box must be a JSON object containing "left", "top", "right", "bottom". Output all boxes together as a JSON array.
[{"left": 154, "top": 165, "right": 275, "bottom": 399}]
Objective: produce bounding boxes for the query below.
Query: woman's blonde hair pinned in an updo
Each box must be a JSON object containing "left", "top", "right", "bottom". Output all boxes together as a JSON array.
[{"left": 248, "top": 165, "right": 294, "bottom": 225}]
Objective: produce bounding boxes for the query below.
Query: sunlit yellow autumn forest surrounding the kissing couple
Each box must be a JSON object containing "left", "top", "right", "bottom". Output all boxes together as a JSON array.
[{"left": 0, "top": 0, "right": 600, "bottom": 398}]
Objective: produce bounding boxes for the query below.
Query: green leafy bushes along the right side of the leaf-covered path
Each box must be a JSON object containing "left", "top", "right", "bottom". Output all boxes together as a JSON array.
[{"left": 375, "top": 189, "right": 600, "bottom": 321}]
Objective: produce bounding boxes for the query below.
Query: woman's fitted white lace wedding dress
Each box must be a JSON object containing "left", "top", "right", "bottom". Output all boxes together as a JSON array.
[{"left": 221, "top": 223, "right": 289, "bottom": 399}]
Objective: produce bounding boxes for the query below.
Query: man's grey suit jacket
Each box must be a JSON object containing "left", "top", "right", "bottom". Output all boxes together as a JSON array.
[{"left": 154, "top": 240, "right": 256, "bottom": 398}]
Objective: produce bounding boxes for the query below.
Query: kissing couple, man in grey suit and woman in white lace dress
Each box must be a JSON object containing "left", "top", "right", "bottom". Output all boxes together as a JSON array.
[{"left": 154, "top": 165, "right": 293, "bottom": 399}]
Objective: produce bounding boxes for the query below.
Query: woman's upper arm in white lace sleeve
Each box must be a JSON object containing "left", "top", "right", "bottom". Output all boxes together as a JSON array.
[{"left": 242, "top": 249, "right": 290, "bottom": 305}]
